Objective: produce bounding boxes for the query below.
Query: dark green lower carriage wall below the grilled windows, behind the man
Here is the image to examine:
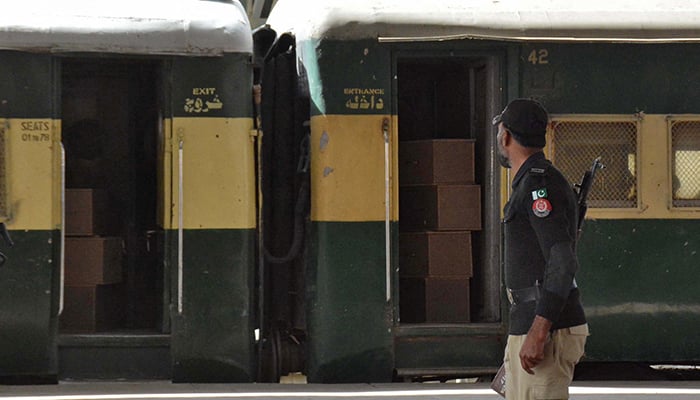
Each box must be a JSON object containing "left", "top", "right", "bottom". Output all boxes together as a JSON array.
[{"left": 578, "top": 220, "right": 700, "bottom": 362}]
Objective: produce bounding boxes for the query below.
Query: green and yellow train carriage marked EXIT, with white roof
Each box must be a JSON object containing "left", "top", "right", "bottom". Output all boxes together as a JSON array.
[{"left": 0, "top": 0, "right": 256, "bottom": 382}]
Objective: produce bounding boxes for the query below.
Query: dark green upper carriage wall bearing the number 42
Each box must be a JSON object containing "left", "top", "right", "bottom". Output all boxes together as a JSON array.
[{"left": 511, "top": 43, "right": 700, "bottom": 114}]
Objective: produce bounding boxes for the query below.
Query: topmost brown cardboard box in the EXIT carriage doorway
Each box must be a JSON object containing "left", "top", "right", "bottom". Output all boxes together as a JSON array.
[{"left": 64, "top": 189, "right": 115, "bottom": 236}]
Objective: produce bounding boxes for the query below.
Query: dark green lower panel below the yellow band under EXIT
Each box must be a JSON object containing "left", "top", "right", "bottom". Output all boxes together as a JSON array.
[{"left": 166, "top": 230, "right": 256, "bottom": 382}]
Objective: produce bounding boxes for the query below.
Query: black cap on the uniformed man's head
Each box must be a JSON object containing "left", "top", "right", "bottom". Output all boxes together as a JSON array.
[{"left": 493, "top": 99, "right": 549, "bottom": 148}]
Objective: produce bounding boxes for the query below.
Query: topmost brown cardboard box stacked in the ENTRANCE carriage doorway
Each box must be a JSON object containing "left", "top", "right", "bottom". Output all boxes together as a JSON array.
[{"left": 399, "top": 139, "right": 474, "bottom": 185}]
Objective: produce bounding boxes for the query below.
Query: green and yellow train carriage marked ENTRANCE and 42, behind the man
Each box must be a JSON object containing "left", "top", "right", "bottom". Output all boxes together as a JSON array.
[{"left": 255, "top": 1, "right": 700, "bottom": 382}]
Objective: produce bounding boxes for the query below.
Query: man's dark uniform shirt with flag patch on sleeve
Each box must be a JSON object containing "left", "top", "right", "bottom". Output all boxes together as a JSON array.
[{"left": 503, "top": 152, "right": 586, "bottom": 335}]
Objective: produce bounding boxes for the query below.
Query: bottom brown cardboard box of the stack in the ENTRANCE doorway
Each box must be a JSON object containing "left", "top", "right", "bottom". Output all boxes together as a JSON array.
[{"left": 399, "top": 277, "right": 471, "bottom": 323}]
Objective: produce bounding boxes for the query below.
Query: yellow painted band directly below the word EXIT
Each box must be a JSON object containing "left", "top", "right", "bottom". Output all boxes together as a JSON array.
[{"left": 159, "top": 118, "right": 256, "bottom": 229}]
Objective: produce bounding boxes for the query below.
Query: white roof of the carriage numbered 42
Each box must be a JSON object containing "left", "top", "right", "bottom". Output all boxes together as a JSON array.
[{"left": 268, "top": 0, "right": 700, "bottom": 43}]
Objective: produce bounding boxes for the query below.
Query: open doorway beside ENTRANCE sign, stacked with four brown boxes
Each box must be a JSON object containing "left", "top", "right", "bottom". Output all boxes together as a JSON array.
[{"left": 394, "top": 51, "right": 505, "bottom": 379}]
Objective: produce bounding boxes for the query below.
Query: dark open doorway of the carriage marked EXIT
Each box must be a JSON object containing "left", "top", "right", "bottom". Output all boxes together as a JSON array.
[{"left": 56, "top": 55, "right": 170, "bottom": 378}]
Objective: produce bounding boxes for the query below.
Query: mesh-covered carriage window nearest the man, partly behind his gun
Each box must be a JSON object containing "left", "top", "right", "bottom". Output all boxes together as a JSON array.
[{"left": 550, "top": 118, "right": 638, "bottom": 208}]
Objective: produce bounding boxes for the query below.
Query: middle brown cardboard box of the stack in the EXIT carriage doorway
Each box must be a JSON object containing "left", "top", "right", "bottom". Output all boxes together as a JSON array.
[{"left": 65, "top": 236, "right": 122, "bottom": 286}]
